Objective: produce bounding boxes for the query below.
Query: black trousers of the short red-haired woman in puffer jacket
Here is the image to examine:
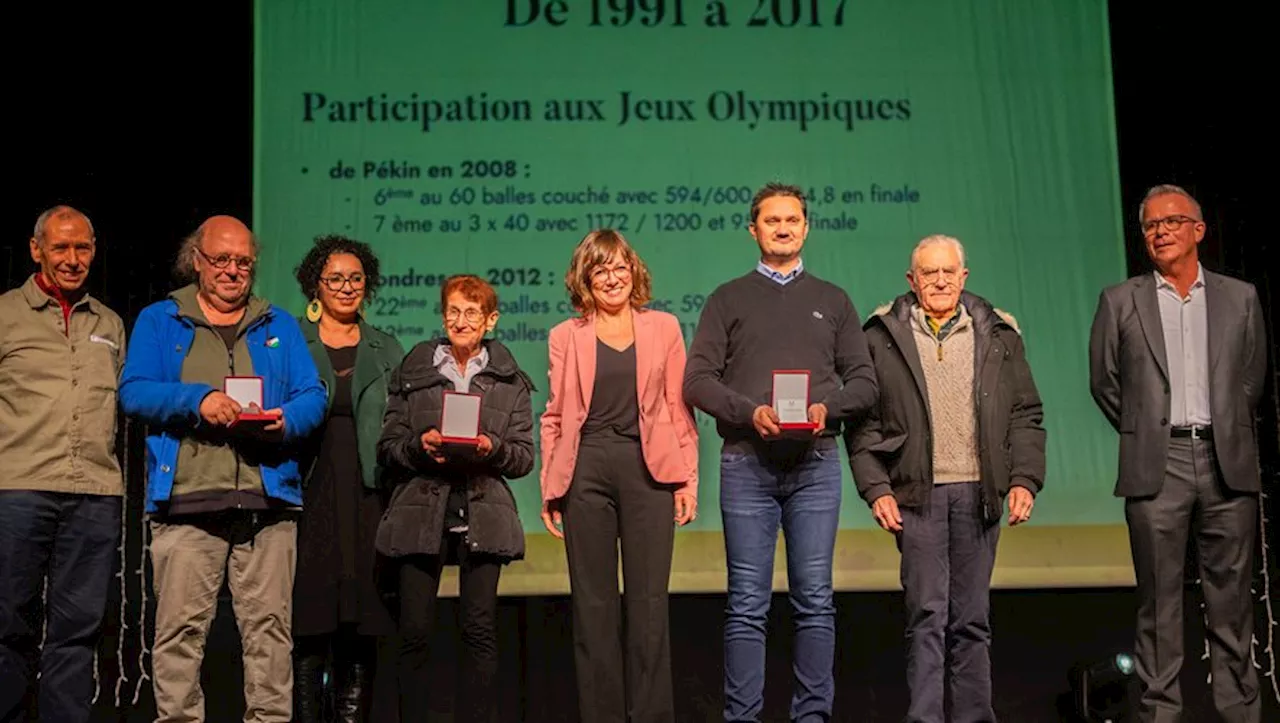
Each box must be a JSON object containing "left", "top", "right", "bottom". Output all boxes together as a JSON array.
[{"left": 398, "top": 532, "right": 502, "bottom": 723}]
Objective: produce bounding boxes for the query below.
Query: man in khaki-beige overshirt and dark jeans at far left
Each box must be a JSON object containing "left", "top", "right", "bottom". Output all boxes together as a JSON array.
[{"left": 0, "top": 206, "right": 124, "bottom": 723}]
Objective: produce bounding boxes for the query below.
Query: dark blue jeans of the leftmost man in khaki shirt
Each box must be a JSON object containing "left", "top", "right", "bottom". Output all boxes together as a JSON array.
[{"left": 0, "top": 490, "right": 120, "bottom": 722}]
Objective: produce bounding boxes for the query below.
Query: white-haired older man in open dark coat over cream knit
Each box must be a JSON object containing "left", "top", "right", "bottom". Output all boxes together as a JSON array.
[{"left": 845, "top": 235, "right": 1044, "bottom": 723}]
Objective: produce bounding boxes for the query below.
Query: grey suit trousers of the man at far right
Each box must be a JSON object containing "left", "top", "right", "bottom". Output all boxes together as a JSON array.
[{"left": 1125, "top": 438, "right": 1262, "bottom": 723}]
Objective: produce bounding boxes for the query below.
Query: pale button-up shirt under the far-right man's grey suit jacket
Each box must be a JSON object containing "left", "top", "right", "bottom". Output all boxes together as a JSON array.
[{"left": 1155, "top": 266, "right": 1213, "bottom": 426}]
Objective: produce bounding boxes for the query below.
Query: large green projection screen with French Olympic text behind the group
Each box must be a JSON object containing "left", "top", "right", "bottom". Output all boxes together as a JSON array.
[{"left": 253, "top": 0, "right": 1133, "bottom": 594}]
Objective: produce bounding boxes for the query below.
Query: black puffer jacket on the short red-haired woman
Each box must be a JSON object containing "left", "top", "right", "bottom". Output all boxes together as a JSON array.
[{"left": 376, "top": 339, "right": 534, "bottom": 562}]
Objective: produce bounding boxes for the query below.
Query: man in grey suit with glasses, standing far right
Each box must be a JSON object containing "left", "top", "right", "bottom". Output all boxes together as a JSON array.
[{"left": 1089, "top": 186, "right": 1267, "bottom": 723}]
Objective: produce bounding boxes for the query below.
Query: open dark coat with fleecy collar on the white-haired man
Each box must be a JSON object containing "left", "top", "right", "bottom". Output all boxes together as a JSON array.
[{"left": 845, "top": 292, "right": 1044, "bottom": 523}]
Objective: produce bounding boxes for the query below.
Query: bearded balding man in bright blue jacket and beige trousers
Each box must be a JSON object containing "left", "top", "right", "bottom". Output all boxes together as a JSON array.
[{"left": 120, "top": 216, "right": 325, "bottom": 722}]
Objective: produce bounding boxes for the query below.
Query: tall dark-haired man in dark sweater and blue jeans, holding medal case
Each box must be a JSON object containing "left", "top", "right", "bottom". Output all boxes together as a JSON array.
[{"left": 685, "top": 183, "right": 877, "bottom": 722}]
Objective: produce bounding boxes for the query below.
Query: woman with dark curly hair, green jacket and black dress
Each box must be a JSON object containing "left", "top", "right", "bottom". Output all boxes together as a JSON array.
[{"left": 293, "top": 235, "right": 404, "bottom": 723}]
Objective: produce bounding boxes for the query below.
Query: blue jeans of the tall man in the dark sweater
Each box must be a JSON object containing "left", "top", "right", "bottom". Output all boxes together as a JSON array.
[{"left": 721, "top": 439, "right": 841, "bottom": 723}]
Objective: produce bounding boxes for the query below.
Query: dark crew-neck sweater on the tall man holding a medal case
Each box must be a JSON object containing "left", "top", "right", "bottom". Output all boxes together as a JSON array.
[{"left": 685, "top": 271, "right": 877, "bottom": 444}]
